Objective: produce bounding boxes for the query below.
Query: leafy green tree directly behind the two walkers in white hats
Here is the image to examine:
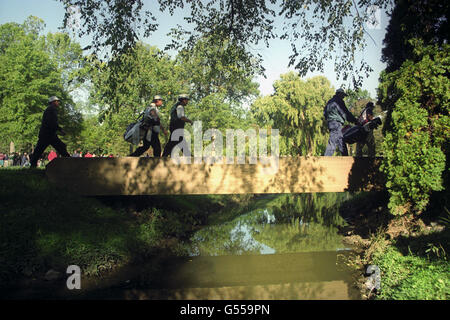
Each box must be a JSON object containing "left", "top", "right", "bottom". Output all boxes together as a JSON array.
[{"left": 83, "top": 43, "right": 188, "bottom": 154}]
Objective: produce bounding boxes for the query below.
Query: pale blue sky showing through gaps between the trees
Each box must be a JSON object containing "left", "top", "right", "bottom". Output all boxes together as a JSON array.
[{"left": 0, "top": 0, "right": 389, "bottom": 98}]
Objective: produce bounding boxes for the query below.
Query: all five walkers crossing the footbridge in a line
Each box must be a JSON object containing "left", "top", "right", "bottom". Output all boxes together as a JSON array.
[{"left": 29, "top": 89, "right": 375, "bottom": 168}]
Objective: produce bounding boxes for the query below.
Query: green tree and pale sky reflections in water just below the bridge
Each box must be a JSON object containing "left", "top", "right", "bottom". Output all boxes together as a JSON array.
[{"left": 190, "top": 193, "right": 349, "bottom": 256}]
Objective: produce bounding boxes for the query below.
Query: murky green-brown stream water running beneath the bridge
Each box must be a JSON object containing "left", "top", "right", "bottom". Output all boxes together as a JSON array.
[{"left": 4, "top": 194, "right": 359, "bottom": 300}]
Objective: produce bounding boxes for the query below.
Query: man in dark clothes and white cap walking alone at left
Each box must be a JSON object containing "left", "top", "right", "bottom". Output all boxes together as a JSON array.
[{"left": 30, "top": 96, "right": 70, "bottom": 168}]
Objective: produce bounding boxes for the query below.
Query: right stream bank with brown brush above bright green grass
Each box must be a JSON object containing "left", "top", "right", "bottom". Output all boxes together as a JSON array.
[{"left": 342, "top": 190, "right": 450, "bottom": 300}]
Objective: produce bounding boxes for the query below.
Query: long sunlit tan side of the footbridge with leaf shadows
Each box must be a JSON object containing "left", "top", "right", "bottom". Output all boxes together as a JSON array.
[{"left": 46, "top": 157, "right": 384, "bottom": 196}]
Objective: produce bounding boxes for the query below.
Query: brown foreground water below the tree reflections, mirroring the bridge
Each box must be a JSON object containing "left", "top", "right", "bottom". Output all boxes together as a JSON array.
[{"left": 77, "top": 251, "right": 358, "bottom": 300}]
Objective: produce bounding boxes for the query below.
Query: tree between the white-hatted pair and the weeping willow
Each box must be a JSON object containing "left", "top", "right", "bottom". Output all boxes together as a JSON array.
[{"left": 177, "top": 34, "right": 259, "bottom": 152}]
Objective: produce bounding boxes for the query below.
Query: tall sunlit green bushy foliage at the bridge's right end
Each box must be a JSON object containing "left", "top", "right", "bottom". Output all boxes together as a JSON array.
[{"left": 378, "top": 41, "right": 450, "bottom": 214}]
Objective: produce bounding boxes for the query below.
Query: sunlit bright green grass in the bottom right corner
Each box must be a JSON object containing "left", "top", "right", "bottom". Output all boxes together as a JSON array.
[{"left": 372, "top": 231, "right": 450, "bottom": 300}]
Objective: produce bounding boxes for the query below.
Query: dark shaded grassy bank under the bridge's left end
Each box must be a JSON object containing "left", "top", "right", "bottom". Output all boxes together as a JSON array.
[{"left": 0, "top": 168, "right": 253, "bottom": 285}]
